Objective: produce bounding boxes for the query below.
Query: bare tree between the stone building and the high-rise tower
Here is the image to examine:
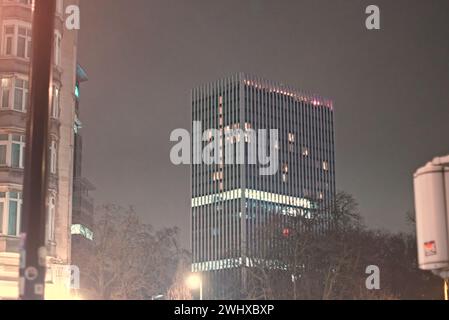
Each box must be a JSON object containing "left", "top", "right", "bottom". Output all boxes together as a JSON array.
[{"left": 76, "top": 205, "right": 186, "bottom": 300}]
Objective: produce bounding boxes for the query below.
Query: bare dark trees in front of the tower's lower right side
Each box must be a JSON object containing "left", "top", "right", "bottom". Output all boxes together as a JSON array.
[{"left": 242, "top": 193, "right": 435, "bottom": 300}]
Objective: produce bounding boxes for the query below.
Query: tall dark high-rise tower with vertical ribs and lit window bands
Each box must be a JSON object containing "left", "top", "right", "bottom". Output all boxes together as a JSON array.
[{"left": 191, "top": 73, "right": 335, "bottom": 298}]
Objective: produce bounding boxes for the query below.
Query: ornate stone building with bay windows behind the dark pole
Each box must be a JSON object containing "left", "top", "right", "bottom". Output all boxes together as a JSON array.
[{"left": 0, "top": 0, "right": 78, "bottom": 299}]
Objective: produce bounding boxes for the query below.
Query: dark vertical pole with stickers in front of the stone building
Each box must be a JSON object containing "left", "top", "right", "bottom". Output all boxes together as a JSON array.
[{"left": 19, "top": 0, "right": 56, "bottom": 300}]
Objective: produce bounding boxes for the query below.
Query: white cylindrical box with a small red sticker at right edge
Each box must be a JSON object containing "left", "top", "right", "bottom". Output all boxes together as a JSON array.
[{"left": 414, "top": 163, "right": 449, "bottom": 270}]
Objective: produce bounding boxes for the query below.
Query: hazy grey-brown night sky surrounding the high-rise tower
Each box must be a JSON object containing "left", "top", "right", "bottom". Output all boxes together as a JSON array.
[{"left": 79, "top": 0, "right": 449, "bottom": 247}]
